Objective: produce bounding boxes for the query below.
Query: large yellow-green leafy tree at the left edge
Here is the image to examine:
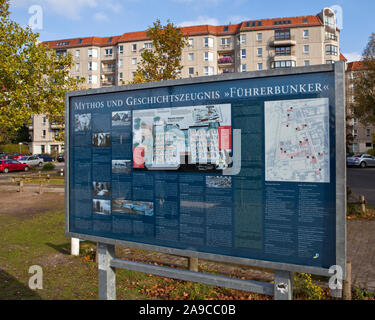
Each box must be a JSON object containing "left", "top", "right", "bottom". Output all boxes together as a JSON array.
[{"left": 0, "top": 0, "right": 82, "bottom": 143}]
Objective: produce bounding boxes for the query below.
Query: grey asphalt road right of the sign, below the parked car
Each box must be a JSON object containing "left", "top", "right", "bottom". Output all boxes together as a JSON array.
[{"left": 347, "top": 168, "right": 375, "bottom": 207}]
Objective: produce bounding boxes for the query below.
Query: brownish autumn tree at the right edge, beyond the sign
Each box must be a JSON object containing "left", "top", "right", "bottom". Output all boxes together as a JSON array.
[{"left": 353, "top": 33, "right": 375, "bottom": 124}]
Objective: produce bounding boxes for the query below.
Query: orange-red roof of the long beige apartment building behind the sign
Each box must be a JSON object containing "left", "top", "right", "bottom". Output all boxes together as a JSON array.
[{"left": 44, "top": 16, "right": 323, "bottom": 49}]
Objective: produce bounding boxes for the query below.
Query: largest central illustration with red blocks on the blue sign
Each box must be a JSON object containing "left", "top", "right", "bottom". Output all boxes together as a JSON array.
[{"left": 133, "top": 104, "right": 232, "bottom": 173}]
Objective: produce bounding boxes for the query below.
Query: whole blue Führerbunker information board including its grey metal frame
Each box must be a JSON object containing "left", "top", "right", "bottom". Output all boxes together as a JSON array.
[{"left": 67, "top": 64, "right": 345, "bottom": 273}]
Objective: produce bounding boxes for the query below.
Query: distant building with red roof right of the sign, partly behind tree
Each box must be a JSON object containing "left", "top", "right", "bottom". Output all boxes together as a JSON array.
[{"left": 346, "top": 61, "right": 375, "bottom": 153}]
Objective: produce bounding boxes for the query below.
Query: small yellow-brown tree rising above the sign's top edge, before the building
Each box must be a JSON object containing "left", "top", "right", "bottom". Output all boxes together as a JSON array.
[{"left": 133, "top": 20, "right": 188, "bottom": 83}]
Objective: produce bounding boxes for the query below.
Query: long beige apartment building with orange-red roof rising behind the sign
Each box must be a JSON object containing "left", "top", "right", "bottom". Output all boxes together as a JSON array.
[{"left": 29, "top": 8, "right": 340, "bottom": 153}]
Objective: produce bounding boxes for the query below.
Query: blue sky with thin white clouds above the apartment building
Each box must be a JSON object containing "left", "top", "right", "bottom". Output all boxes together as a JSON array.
[{"left": 10, "top": 0, "right": 375, "bottom": 61}]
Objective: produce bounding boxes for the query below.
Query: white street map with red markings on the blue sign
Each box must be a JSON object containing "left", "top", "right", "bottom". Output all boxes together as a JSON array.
[{"left": 265, "top": 98, "right": 330, "bottom": 183}]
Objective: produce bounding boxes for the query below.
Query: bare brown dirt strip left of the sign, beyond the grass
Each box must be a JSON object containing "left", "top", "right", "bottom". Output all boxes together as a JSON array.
[{"left": 0, "top": 191, "right": 64, "bottom": 219}]
